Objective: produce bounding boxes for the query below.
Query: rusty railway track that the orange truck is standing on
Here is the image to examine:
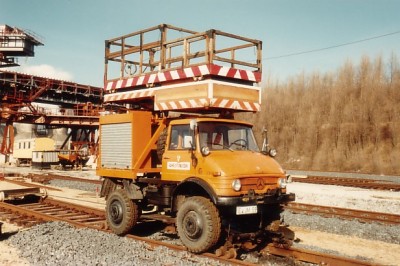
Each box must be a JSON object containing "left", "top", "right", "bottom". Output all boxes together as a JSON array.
[{"left": 0, "top": 198, "right": 380, "bottom": 266}]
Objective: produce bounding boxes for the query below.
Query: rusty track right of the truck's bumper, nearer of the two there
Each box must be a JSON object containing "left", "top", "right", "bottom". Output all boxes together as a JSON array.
[{"left": 285, "top": 202, "right": 400, "bottom": 225}]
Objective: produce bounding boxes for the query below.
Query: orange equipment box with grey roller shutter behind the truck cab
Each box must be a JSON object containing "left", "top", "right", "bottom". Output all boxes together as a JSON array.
[{"left": 97, "top": 111, "right": 152, "bottom": 178}]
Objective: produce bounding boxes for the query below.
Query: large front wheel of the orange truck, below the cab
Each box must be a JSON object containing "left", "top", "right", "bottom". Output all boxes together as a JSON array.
[{"left": 176, "top": 196, "right": 221, "bottom": 253}]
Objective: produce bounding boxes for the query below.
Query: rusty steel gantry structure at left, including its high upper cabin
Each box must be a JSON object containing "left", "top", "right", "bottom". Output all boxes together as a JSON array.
[{"left": 0, "top": 25, "right": 115, "bottom": 164}]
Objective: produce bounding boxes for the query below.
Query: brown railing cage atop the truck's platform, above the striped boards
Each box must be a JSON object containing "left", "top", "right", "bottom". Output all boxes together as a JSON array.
[{"left": 105, "top": 24, "right": 262, "bottom": 89}]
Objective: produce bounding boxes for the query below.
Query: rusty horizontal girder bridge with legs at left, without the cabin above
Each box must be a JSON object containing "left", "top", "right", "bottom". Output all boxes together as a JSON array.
[{"left": 0, "top": 70, "right": 109, "bottom": 160}]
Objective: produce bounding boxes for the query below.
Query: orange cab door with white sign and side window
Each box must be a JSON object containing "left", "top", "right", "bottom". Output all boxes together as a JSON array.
[{"left": 161, "top": 125, "right": 195, "bottom": 181}]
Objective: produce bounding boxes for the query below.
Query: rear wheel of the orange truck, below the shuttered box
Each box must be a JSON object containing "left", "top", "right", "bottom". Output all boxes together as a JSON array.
[{"left": 106, "top": 189, "right": 140, "bottom": 235}]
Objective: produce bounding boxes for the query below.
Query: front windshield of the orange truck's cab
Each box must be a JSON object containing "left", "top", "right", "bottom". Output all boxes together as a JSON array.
[{"left": 198, "top": 122, "right": 259, "bottom": 152}]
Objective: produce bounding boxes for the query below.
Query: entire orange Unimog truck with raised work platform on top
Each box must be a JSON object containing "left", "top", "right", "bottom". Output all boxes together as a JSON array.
[{"left": 97, "top": 24, "right": 295, "bottom": 256}]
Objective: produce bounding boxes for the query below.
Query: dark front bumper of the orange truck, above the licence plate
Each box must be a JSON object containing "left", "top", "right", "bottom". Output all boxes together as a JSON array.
[{"left": 216, "top": 193, "right": 296, "bottom": 207}]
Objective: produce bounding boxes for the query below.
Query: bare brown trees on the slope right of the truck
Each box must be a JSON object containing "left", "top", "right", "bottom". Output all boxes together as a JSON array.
[{"left": 239, "top": 54, "right": 400, "bottom": 175}]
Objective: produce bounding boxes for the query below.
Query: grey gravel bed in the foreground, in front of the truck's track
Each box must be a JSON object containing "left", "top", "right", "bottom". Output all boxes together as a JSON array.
[{"left": 6, "top": 222, "right": 224, "bottom": 266}]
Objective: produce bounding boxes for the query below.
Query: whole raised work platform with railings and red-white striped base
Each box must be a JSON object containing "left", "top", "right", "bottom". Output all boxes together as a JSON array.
[{"left": 104, "top": 24, "right": 262, "bottom": 113}]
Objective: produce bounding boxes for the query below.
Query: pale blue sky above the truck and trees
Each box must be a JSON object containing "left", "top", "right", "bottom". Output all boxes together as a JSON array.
[{"left": 0, "top": 0, "right": 400, "bottom": 86}]
